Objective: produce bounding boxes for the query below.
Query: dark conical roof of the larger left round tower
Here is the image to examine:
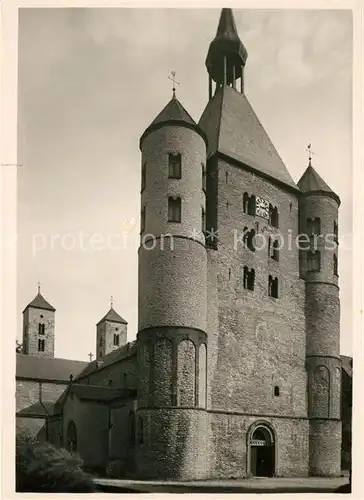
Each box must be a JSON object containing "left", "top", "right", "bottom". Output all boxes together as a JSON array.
[{"left": 140, "top": 95, "right": 206, "bottom": 146}]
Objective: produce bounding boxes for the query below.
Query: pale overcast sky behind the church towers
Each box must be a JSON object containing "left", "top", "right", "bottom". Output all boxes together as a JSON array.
[{"left": 18, "top": 8, "right": 352, "bottom": 360}]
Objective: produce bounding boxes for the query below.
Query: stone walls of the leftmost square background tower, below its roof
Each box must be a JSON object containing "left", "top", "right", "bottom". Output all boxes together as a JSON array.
[{"left": 23, "top": 307, "right": 55, "bottom": 358}]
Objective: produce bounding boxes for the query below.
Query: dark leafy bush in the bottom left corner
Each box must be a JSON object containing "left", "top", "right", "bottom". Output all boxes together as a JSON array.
[{"left": 16, "top": 435, "right": 97, "bottom": 493}]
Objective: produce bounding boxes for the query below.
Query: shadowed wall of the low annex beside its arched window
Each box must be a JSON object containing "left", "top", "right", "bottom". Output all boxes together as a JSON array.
[{"left": 63, "top": 395, "right": 109, "bottom": 469}]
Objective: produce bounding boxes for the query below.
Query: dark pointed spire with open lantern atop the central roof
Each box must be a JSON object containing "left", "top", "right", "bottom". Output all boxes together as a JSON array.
[{"left": 206, "top": 9, "right": 248, "bottom": 99}]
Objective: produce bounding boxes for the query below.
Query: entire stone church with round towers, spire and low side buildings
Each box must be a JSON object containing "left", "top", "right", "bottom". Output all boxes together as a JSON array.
[{"left": 16, "top": 9, "right": 351, "bottom": 480}]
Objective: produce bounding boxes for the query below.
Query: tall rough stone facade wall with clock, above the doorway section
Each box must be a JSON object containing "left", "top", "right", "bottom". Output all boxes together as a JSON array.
[{"left": 207, "top": 161, "right": 307, "bottom": 417}]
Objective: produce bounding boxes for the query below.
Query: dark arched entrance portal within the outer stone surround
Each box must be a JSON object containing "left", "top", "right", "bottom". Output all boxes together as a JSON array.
[{"left": 249, "top": 425, "right": 275, "bottom": 477}]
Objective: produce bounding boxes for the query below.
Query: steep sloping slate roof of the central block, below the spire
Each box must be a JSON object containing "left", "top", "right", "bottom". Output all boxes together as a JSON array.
[{"left": 199, "top": 85, "right": 298, "bottom": 191}]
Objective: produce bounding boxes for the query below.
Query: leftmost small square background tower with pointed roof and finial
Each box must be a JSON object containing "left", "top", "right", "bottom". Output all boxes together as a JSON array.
[{"left": 23, "top": 282, "right": 56, "bottom": 358}]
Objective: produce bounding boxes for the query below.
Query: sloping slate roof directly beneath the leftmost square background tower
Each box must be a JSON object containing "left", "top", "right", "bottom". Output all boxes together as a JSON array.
[{"left": 16, "top": 354, "right": 89, "bottom": 382}]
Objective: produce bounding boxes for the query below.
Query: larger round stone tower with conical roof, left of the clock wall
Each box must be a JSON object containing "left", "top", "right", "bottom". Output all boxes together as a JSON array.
[{"left": 136, "top": 93, "right": 208, "bottom": 479}]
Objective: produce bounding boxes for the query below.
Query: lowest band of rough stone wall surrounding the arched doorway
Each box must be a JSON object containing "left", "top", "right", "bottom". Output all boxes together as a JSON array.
[{"left": 210, "top": 413, "right": 309, "bottom": 479}]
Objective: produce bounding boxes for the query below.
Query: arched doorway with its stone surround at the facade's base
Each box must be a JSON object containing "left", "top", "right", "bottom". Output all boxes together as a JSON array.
[{"left": 247, "top": 421, "right": 277, "bottom": 477}]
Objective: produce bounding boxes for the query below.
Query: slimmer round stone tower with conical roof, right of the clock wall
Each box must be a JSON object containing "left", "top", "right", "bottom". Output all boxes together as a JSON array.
[{"left": 298, "top": 161, "right": 341, "bottom": 476}]
